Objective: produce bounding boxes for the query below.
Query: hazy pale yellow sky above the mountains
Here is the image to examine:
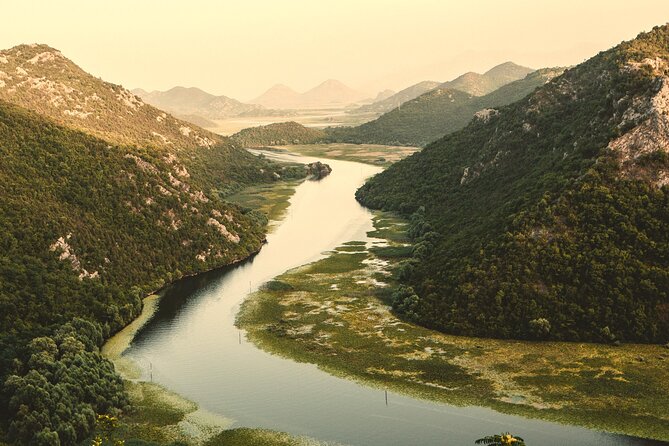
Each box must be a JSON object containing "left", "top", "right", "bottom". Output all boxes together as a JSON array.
[{"left": 0, "top": 0, "right": 669, "bottom": 100}]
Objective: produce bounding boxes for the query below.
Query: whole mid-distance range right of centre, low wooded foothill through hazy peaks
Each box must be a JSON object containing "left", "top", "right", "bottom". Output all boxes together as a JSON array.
[{"left": 233, "top": 62, "right": 564, "bottom": 147}]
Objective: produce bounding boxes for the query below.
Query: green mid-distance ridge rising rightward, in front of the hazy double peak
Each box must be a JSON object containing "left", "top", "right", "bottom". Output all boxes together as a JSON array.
[{"left": 327, "top": 68, "right": 562, "bottom": 146}]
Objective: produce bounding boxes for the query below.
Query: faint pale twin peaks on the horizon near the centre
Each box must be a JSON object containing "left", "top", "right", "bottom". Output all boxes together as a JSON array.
[{"left": 251, "top": 79, "right": 365, "bottom": 109}]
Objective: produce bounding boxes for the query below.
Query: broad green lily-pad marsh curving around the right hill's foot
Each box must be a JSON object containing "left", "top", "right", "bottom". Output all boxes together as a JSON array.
[{"left": 238, "top": 214, "right": 669, "bottom": 440}]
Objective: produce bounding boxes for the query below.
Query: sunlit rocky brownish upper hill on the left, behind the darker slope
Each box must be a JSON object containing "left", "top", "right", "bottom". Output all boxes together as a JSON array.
[{"left": 0, "top": 45, "right": 288, "bottom": 195}]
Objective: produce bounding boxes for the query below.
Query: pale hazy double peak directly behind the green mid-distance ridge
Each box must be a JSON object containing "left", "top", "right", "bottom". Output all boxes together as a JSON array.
[{"left": 440, "top": 62, "right": 534, "bottom": 96}]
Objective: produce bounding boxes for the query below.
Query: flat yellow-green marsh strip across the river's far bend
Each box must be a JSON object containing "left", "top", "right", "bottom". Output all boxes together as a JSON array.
[{"left": 276, "top": 143, "right": 420, "bottom": 166}]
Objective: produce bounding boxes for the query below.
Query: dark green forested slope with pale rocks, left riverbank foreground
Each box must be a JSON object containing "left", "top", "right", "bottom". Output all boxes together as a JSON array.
[{"left": 0, "top": 102, "right": 298, "bottom": 445}]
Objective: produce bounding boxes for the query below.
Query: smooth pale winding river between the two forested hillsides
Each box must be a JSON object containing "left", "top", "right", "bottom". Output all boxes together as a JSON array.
[{"left": 127, "top": 152, "right": 667, "bottom": 446}]
